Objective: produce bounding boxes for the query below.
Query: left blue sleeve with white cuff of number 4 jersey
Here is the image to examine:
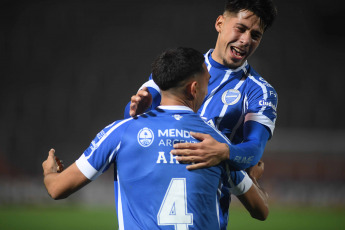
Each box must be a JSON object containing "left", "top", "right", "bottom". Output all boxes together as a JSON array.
[{"left": 76, "top": 118, "right": 132, "bottom": 180}]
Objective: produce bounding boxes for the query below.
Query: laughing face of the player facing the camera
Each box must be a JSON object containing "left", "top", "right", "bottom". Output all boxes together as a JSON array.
[{"left": 212, "top": 10, "right": 264, "bottom": 69}]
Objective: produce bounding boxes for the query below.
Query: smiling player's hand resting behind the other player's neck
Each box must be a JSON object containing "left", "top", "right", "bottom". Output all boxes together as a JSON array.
[{"left": 129, "top": 87, "right": 152, "bottom": 117}]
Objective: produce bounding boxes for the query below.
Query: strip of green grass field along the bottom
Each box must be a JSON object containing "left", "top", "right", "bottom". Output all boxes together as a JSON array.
[{"left": 0, "top": 206, "right": 345, "bottom": 230}]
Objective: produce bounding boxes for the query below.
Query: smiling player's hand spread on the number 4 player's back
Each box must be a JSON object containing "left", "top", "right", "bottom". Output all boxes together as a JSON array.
[{"left": 171, "top": 132, "right": 229, "bottom": 170}]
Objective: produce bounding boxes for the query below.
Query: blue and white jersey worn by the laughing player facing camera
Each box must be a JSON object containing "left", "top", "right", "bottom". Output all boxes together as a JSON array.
[{"left": 125, "top": 50, "right": 278, "bottom": 169}]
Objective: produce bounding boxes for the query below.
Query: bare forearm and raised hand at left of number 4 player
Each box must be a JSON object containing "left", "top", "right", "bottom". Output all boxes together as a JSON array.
[{"left": 42, "top": 149, "right": 91, "bottom": 200}]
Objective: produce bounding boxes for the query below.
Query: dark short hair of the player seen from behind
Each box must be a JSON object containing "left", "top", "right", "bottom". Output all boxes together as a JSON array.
[{"left": 152, "top": 47, "right": 205, "bottom": 90}]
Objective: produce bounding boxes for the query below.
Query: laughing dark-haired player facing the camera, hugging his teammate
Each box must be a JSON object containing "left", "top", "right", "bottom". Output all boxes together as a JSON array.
[{"left": 125, "top": 0, "right": 278, "bottom": 228}]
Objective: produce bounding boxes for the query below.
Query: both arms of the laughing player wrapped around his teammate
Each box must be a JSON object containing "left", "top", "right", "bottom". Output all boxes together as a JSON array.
[{"left": 125, "top": 87, "right": 270, "bottom": 170}]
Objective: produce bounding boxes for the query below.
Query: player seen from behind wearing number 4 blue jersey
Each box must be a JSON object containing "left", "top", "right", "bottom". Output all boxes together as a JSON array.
[{"left": 42, "top": 48, "right": 268, "bottom": 230}]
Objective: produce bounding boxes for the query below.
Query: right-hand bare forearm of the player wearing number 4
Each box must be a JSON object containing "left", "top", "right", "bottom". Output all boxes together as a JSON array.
[{"left": 237, "top": 161, "right": 269, "bottom": 220}]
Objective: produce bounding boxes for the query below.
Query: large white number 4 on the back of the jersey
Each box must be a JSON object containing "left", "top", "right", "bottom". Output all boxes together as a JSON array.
[{"left": 157, "top": 178, "right": 193, "bottom": 230}]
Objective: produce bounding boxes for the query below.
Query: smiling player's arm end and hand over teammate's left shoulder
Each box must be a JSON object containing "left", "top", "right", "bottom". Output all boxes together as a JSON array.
[{"left": 124, "top": 80, "right": 161, "bottom": 118}]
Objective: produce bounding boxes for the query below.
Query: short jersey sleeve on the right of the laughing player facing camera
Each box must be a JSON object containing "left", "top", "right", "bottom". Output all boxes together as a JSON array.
[{"left": 245, "top": 76, "right": 278, "bottom": 136}]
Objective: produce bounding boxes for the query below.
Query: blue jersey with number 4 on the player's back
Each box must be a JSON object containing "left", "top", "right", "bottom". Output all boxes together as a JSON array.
[{"left": 76, "top": 106, "right": 252, "bottom": 230}]
